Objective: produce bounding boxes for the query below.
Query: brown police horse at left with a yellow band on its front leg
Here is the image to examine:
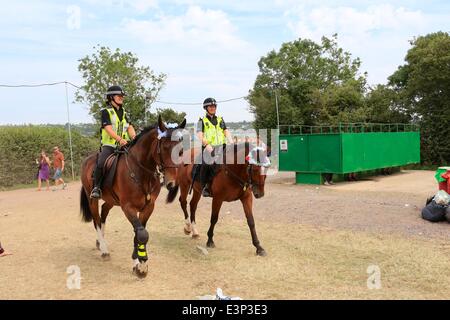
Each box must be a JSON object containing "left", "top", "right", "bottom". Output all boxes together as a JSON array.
[{"left": 80, "top": 117, "right": 186, "bottom": 277}]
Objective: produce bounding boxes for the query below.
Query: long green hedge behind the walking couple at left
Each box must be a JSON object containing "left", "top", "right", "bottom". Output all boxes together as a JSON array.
[{"left": 0, "top": 125, "right": 98, "bottom": 187}]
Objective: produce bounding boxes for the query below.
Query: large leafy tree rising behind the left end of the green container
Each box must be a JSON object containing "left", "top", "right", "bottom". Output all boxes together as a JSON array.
[{"left": 248, "top": 35, "right": 368, "bottom": 128}]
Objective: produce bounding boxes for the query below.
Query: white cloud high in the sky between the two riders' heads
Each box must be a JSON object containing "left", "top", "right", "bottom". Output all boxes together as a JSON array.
[{"left": 123, "top": 6, "right": 246, "bottom": 51}]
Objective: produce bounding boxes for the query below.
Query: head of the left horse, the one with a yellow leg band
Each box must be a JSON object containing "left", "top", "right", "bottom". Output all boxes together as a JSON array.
[{"left": 155, "top": 116, "right": 186, "bottom": 191}]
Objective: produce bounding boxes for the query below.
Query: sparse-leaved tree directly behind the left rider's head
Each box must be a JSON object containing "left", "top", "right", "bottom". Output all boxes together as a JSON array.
[{"left": 75, "top": 46, "right": 166, "bottom": 127}]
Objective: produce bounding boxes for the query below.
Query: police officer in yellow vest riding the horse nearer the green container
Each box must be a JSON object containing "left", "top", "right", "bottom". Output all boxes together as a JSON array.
[{"left": 197, "top": 98, "right": 233, "bottom": 197}]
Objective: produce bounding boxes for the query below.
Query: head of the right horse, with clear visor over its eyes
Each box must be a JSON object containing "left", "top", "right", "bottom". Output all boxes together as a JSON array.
[{"left": 246, "top": 147, "right": 270, "bottom": 199}]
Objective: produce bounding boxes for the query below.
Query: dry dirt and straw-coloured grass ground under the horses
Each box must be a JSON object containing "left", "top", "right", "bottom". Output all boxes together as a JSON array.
[{"left": 0, "top": 171, "right": 450, "bottom": 299}]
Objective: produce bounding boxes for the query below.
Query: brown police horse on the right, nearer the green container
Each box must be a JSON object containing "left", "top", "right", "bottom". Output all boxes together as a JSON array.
[{"left": 178, "top": 144, "right": 268, "bottom": 256}]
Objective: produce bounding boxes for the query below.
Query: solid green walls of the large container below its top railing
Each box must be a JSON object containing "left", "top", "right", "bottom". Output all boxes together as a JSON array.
[{"left": 280, "top": 131, "right": 420, "bottom": 174}]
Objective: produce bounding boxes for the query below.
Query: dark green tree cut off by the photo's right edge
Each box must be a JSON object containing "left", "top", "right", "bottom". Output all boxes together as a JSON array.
[{"left": 389, "top": 32, "right": 450, "bottom": 164}]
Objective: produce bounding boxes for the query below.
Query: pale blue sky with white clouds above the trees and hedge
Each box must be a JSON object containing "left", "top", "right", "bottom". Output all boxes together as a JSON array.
[{"left": 0, "top": 0, "right": 450, "bottom": 124}]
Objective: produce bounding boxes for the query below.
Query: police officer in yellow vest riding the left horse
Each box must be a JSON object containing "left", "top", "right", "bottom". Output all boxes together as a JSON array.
[{"left": 91, "top": 86, "right": 136, "bottom": 199}]
